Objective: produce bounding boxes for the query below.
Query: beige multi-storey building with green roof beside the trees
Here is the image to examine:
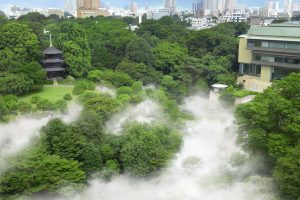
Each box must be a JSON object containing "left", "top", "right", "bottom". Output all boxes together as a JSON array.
[{"left": 238, "top": 22, "right": 300, "bottom": 92}]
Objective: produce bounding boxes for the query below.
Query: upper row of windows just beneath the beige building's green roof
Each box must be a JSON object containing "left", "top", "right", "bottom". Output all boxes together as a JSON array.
[{"left": 248, "top": 40, "right": 300, "bottom": 50}]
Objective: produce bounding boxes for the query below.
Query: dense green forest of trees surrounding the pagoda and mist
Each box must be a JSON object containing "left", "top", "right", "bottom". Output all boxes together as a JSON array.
[{"left": 0, "top": 13, "right": 300, "bottom": 200}]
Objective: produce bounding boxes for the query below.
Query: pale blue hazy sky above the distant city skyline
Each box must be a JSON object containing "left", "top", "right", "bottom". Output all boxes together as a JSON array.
[{"left": 0, "top": 0, "right": 294, "bottom": 11}]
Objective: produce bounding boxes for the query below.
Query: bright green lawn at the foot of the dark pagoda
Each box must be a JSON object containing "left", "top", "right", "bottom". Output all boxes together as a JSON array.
[{"left": 20, "top": 85, "right": 74, "bottom": 102}]
